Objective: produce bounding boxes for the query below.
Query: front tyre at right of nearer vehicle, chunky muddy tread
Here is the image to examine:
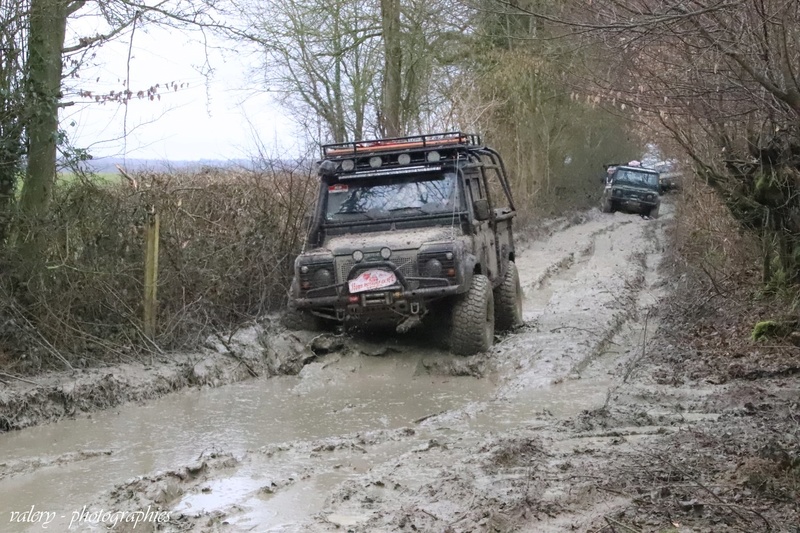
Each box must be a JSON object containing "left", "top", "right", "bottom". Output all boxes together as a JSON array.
[{"left": 450, "top": 274, "right": 494, "bottom": 355}]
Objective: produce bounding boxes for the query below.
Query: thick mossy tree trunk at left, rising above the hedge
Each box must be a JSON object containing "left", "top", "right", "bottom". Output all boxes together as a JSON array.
[{"left": 20, "top": 0, "right": 68, "bottom": 224}]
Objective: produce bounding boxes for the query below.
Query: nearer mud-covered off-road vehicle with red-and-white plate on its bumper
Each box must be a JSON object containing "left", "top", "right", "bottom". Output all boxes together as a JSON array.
[{"left": 289, "top": 132, "right": 522, "bottom": 355}]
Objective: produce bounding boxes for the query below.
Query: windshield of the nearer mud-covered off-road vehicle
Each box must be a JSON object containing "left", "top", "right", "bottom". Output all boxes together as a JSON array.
[{"left": 325, "top": 172, "right": 460, "bottom": 222}]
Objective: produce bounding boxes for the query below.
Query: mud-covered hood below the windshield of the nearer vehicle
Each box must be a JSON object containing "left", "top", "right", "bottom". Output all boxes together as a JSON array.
[{"left": 323, "top": 226, "right": 460, "bottom": 255}]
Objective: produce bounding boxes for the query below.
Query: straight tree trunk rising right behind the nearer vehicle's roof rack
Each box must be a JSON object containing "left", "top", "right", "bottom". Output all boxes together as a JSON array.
[{"left": 380, "top": 0, "right": 404, "bottom": 137}]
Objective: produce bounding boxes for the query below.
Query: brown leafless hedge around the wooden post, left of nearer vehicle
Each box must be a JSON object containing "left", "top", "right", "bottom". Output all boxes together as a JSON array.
[{"left": 0, "top": 168, "right": 315, "bottom": 371}]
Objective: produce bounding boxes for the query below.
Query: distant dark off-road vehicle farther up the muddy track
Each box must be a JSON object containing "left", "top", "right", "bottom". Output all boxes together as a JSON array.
[{"left": 601, "top": 165, "right": 661, "bottom": 218}]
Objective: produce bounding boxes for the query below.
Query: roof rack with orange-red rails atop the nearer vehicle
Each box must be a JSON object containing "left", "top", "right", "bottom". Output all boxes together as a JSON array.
[{"left": 322, "top": 131, "right": 481, "bottom": 159}]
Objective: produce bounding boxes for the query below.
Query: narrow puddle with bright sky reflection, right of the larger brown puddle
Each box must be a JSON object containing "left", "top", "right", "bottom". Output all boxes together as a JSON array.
[{"left": 195, "top": 374, "right": 624, "bottom": 531}]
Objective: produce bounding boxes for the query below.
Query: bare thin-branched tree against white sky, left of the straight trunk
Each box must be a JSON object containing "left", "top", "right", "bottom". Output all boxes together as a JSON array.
[{"left": 241, "top": 0, "right": 380, "bottom": 142}]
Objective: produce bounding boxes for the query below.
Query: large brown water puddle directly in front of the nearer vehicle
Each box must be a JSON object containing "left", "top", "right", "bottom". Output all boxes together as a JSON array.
[{"left": 0, "top": 354, "right": 492, "bottom": 530}]
